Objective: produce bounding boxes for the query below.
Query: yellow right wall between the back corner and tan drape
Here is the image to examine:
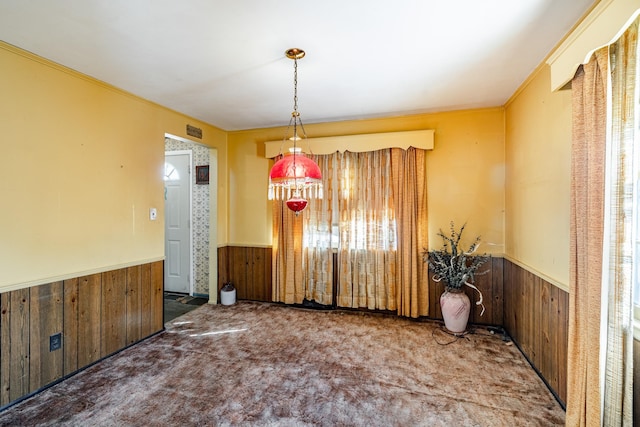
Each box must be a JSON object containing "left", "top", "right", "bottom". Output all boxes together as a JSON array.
[{"left": 505, "top": 65, "right": 571, "bottom": 289}]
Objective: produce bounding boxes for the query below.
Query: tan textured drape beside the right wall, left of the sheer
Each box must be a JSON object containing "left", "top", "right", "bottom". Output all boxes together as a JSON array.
[{"left": 566, "top": 48, "right": 608, "bottom": 426}]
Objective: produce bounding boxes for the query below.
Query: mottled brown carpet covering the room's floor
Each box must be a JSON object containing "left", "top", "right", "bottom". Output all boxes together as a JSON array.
[{"left": 0, "top": 302, "right": 564, "bottom": 426}]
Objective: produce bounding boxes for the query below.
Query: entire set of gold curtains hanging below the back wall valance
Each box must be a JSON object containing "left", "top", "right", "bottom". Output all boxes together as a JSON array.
[{"left": 273, "top": 148, "right": 429, "bottom": 317}]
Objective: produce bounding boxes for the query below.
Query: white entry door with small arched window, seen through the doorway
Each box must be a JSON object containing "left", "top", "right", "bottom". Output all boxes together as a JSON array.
[{"left": 164, "top": 152, "right": 191, "bottom": 294}]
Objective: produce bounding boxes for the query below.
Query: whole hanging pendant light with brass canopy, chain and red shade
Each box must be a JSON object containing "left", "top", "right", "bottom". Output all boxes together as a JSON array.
[{"left": 269, "top": 48, "right": 322, "bottom": 215}]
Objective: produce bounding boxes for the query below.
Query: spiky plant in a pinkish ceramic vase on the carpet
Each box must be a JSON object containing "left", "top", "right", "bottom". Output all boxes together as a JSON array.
[{"left": 422, "top": 221, "right": 489, "bottom": 334}]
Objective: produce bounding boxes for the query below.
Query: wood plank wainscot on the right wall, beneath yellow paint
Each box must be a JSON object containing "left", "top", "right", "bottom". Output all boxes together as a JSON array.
[{"left": 504, "top": 260, "right": 569, "bottom": 402}]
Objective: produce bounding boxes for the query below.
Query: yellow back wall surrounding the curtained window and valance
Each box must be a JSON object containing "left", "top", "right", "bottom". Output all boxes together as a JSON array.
[{"left": 228, "top": 108, "right": 504, "bottom": 254}]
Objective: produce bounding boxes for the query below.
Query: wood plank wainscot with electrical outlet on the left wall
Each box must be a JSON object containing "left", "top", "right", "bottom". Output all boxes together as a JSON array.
[{"left": 0, "top": 261, "right": 163, "bottom": 406}]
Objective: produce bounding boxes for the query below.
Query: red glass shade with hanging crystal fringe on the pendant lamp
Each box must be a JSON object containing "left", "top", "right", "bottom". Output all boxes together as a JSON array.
[{"left": 269, "top": 148, "right": 322, "bottom": 214}]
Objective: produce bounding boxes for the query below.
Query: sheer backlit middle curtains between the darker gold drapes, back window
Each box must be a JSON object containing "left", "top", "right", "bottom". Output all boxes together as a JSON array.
[{"left": 303, "top": 149, "right": 397, "bottom": 309}]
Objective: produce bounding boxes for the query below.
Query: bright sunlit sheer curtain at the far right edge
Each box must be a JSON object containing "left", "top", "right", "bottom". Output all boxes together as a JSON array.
[{"left": 601, "top": 21, "right": 640, "bottom": 426}]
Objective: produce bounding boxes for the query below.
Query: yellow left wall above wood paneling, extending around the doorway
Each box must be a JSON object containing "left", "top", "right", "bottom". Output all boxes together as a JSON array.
[{"left": 0, "top": 42, "right": 227, "bottom": 291}]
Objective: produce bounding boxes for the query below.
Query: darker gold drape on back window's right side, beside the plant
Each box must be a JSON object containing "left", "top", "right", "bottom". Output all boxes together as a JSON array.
[{"left": 391, "top": 148, "right": 429, "bottom": 317}]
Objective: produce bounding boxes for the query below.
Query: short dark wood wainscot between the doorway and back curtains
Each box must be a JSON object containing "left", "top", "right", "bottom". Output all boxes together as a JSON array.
[{"left": 218, "top": 246, "right": 272, "bottom": 302}]
